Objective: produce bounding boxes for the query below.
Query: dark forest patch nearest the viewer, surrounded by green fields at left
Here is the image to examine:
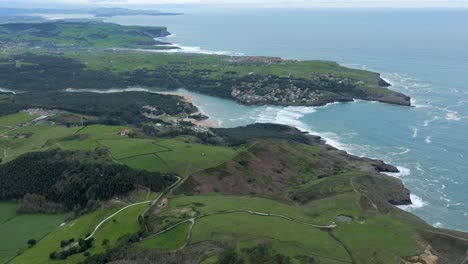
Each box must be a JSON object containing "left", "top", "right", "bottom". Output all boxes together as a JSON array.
[{"left": 0, "top": 150, "right": 175, "bottom": 210}]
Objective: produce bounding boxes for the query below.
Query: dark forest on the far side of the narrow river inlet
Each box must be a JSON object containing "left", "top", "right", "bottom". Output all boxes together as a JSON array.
[{"left": 0, "top": 53, "right": 180, "bottom": 91}]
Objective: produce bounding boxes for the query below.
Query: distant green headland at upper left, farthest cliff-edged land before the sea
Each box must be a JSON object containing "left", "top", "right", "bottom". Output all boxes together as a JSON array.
[{"left": 0, "top": 21, "right": 169, "bottom": 51}]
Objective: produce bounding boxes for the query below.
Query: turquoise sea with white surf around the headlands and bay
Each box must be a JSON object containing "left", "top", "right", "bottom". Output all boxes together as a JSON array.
[{"left": 108, "top": 9, "right": 468, "bottom": 231}]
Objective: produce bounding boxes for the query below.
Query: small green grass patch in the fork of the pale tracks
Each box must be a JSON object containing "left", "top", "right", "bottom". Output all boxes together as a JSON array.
[{"left": 137, "top": 223, "right": 190, "bottom": 251}]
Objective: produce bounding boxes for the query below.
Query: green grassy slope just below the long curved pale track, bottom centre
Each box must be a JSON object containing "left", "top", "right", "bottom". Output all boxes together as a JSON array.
[{"left": 191, "top": 213, "right": 350, "bottom": 261}]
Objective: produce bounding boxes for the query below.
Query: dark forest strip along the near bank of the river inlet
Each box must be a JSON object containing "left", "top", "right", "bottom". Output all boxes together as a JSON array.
[{"left": 0, "top": 91, "right": 197, "bottom": 125}]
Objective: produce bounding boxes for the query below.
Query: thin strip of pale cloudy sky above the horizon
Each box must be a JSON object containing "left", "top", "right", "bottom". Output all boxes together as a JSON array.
[{"left": 0, "top": 0, "right": 468, "bottom": 8}]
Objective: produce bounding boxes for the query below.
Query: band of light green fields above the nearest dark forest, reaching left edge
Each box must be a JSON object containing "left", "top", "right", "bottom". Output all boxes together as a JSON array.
[{"left": 0, "top": 116, "right": 238, "bottom": 176}]
